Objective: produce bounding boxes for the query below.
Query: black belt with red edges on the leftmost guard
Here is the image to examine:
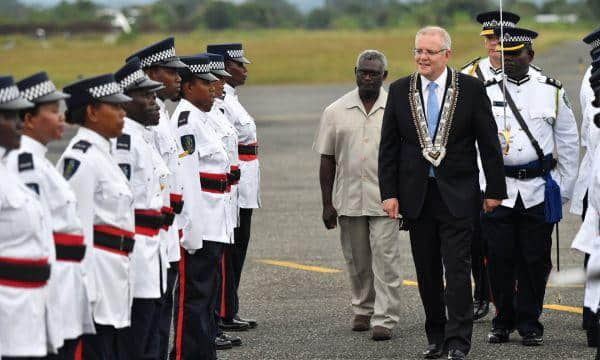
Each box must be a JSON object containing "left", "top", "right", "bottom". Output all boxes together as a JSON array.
[{"left": 0, "top": 257, "right": 50, "bottom": 288}]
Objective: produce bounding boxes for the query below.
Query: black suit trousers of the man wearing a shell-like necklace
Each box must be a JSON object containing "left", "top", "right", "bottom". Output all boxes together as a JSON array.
[{"left": 408, "top": 178, "right": 474, "bottom": 354}]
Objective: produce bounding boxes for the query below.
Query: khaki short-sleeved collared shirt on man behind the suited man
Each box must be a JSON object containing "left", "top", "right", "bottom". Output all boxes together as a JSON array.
[{"left": 313, "top": 88, "right": 387, "bottom": 216}]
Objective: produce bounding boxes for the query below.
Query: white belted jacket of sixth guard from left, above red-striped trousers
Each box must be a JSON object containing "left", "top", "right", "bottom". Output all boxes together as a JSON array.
[{"left": 172, "top": 99, "right": 233, "bottom": 250}]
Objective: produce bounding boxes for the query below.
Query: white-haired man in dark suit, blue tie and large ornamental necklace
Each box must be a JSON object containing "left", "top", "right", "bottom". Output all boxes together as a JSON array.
[{"left": 379, "top": 27, "right": 506, "bottom": 359}]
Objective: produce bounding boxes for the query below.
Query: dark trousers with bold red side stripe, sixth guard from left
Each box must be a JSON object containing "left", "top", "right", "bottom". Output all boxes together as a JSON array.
[{"left": 170, "top": 241, "right": 223, "bottom": 360}]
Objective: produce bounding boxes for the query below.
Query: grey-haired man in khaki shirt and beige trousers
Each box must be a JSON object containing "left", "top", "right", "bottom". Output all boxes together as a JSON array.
[{"left": 313, "top": 50, "right": 402, "bottom": 340}]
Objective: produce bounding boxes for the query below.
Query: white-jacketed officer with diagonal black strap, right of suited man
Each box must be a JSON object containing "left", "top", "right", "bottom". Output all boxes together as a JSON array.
[{"left": 482, "top": 28, "right": 579, "bottom": 346}]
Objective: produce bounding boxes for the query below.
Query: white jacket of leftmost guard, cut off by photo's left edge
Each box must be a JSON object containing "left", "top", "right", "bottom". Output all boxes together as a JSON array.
[{"left": 0, "top": 147, "right": 53, "bottom": 357}]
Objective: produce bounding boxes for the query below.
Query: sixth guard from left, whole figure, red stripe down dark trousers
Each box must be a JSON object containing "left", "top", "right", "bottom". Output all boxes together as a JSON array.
[{"left": 171, "top": 55, "right": 227, "bottom": 360}]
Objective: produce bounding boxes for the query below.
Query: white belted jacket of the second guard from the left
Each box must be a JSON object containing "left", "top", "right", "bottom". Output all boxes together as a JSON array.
[{"left": 7, "top": 135, "right": 95, "bottom": 340}]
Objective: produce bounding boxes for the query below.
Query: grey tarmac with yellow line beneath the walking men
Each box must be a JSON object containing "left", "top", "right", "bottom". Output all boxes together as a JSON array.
[{"left": 51, "top": 43, "right": 595, "bottom": 360}]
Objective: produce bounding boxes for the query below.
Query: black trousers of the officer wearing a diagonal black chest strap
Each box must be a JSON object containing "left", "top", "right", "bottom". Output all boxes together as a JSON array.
[{"left": 482, "top": 196, "right": 553, "bottom": 335}]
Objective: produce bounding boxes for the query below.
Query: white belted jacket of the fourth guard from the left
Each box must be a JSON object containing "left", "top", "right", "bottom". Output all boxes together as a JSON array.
[{"left": 111, "top": 118, "right": 169, "bottom": 299}]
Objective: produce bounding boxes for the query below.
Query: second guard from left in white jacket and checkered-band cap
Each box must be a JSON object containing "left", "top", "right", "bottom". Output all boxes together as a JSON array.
[{"left": 8, "top": 72, "right": 95, "bottom": 359}]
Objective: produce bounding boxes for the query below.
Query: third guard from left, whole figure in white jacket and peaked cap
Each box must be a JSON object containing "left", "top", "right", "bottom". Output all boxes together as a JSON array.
[{"left": 57, "top": 74, "right": 135, "bottom": 359}]
